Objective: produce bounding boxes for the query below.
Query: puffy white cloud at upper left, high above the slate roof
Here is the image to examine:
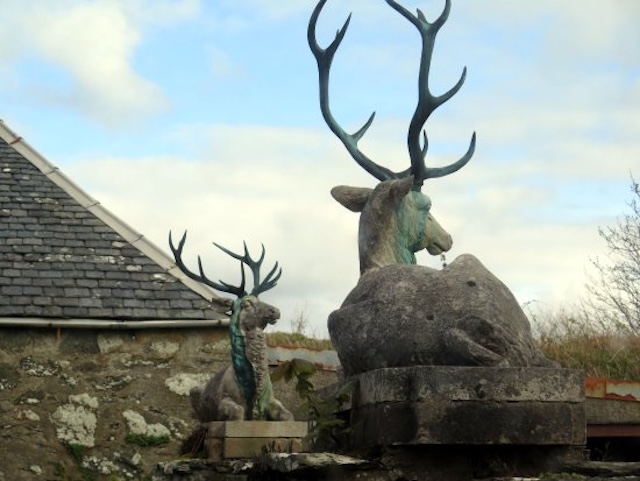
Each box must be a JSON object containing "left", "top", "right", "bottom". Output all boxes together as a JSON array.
[{"left": 28, "top": 3, "right": 165, "bottom": 125}]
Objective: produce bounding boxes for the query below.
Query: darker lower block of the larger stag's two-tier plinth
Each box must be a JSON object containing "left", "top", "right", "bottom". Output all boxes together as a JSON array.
[{"left": 351, "top": 399, "right": 586, "bottom": 448}]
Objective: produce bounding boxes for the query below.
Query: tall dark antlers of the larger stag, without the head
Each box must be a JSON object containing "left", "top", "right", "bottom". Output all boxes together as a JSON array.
[{"left": 307, "top": 0, "right": 476, "bottom": 190}]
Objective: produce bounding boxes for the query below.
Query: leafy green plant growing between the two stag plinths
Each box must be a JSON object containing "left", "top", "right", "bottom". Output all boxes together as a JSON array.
[{"left": 271, "top": 359, "right": 355, "bottom": 448}]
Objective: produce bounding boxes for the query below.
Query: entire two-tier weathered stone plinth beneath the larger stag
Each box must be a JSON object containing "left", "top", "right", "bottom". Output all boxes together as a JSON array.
[{"left": 344, "top": 366, "right": 586, "bottom": 447}]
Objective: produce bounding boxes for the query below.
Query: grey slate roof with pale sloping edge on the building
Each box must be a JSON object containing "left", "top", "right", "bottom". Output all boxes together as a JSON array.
[{"left": 0, "top": 121, "right": 226, "bottom": 321}]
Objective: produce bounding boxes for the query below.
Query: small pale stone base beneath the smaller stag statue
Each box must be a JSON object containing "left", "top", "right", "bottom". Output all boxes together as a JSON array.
[{"left": 206, "top": 421, "right": 307, "bottom": 461}]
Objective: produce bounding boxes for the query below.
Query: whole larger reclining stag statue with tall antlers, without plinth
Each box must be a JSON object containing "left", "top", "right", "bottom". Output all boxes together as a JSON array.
[{"left": 307, "top": 0, "right": 553, "bottom": 375}]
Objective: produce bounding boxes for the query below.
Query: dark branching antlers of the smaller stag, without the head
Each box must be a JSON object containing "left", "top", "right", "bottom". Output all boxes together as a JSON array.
[{"left": 169, "top": 231, "right": 282, "bottom": 297}]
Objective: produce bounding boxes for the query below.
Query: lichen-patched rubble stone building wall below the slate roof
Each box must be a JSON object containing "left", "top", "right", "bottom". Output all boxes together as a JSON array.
[{"left": 0, "top": 328, "right": 335, "bottom": 481}]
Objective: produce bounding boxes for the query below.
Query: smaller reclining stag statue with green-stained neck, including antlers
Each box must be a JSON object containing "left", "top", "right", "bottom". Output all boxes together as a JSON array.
[{"left": 169, "top": 232, "right": 293, "bottom": 422}]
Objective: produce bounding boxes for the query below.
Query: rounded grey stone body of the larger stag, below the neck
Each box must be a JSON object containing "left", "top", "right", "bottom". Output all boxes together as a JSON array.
[{"left": 329, "top": 254, "right": 556, "bottom": 376}]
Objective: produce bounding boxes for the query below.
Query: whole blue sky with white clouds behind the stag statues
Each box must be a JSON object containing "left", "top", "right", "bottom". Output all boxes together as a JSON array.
[{"left": 0, "top": 0, "right": 640, "bottom": 337}]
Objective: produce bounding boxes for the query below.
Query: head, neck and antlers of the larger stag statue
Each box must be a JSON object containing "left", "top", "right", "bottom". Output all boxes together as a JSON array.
[{"left": 307, "top": 0, "right": 476, "bottom": 274}]
